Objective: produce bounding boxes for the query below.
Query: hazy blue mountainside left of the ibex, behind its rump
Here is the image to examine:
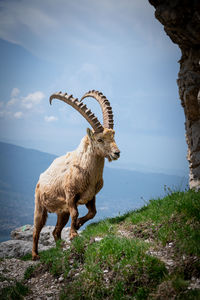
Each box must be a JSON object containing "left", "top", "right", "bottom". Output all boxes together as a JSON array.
[{"left": 0, "top": 142, "right": 56, "bottom": 240}]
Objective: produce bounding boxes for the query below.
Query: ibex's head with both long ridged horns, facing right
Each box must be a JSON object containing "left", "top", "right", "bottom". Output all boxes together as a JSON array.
[{"left": 50, "top": 90, "right": 120, "bottom": 161}]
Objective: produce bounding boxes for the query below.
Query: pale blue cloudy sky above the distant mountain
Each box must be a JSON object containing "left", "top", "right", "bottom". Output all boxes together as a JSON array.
[{"left": 0, "top": 0, "right": 188, "bottom": 175}]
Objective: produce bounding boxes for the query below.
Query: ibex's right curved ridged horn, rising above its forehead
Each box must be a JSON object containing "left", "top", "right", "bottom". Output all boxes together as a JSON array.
[{"left": 81, "top": 90, "right": 114, "bottom": 129}]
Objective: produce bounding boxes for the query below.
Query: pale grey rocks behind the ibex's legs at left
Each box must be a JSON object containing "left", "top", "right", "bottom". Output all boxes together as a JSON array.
[{"left": 0, "top": 225, "right": 70, "bottom": 258}]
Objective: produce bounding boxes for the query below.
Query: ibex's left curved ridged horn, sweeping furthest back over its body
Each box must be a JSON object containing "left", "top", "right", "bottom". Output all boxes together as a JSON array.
[{"left": 49, "top": 92, "right": 103, "bottom": 132}]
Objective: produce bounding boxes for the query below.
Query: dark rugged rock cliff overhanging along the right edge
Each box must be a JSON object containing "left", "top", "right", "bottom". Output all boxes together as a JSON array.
[{"left": 149, "top": 0, "right": 200, "bottom": 189}]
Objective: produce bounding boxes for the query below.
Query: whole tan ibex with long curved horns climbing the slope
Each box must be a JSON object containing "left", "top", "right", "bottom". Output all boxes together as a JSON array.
[{"left": 32, "top": 90, "right": 120, "bottom": 260}]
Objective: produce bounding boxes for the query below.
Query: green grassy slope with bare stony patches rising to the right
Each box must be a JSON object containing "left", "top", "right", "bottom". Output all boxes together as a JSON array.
[{"left": 0, "top": 191, "right": 200, "bottom": 300}]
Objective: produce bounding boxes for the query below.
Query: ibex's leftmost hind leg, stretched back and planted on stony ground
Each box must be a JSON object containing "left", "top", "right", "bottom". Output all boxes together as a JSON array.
[{"left": 32, "top": 201, "right": 47, "bottom": 260}]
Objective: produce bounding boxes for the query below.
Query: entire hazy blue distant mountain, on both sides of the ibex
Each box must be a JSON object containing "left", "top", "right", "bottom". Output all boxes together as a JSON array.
[{"left": 0, "top": 142, "right": 188, "bottom": 241}]
